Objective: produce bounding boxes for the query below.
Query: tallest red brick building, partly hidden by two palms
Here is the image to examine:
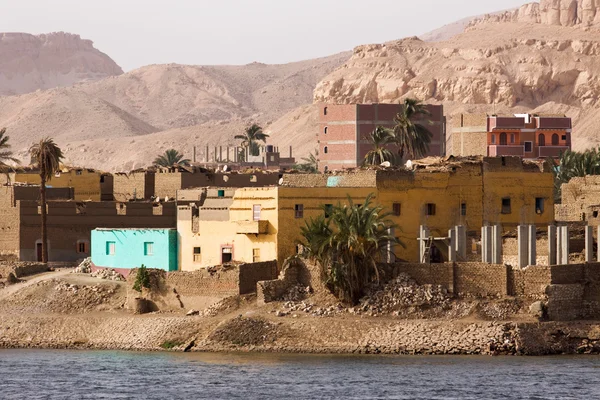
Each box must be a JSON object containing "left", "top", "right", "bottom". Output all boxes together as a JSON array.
[{"left": 317, "top": 104, "right": 446, "bottom": 171}]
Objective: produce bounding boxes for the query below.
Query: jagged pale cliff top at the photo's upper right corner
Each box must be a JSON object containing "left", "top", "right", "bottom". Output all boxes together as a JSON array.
[{"left": 471, "top": 0, "right": 600, "bottom": 27}]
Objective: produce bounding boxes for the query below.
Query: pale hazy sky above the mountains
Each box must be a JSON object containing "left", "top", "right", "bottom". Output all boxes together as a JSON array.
[{"left": 0, "top": 0, "right": 527, "bottom": 71}]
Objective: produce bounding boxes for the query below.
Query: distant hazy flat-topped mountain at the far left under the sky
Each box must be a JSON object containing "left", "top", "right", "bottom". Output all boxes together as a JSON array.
[{"left": 0, "top": 32, "right": 123, "bottom": 95}]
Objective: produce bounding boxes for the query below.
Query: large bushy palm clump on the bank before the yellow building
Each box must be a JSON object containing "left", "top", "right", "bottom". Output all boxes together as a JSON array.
[{"left": 300, "top": 194, "right": 400, "bottom": 304}]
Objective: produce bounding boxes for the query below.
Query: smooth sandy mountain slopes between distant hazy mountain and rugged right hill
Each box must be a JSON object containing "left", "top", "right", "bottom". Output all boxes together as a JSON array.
[{"left": 0, "top": 52, "right": 351, "bottom": 171}]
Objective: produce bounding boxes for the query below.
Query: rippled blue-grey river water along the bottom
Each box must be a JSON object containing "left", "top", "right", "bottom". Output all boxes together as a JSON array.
[{"left": 0, "top": 350, "right": 600, "bottom": 400}]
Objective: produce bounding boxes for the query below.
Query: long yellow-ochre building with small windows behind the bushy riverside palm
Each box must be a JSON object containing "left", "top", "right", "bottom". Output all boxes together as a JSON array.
[{"left": 178, "top": 157, "right": 554, "bottom": 269}]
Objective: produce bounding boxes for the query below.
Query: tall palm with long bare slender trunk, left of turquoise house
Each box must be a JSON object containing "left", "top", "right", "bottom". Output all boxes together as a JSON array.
[{"left": 29, "top": 138, "right": 63, "bottom": 263}]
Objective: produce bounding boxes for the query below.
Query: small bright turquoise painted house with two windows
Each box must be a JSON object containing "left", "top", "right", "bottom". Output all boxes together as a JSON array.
[{"left": 91, "top": 228, "right": 177, "bottom": 271}]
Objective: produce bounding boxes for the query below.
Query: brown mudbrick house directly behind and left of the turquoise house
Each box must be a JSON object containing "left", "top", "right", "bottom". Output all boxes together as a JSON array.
[{"left": 0, "top": 186, "right": 176, "bottom": 261}]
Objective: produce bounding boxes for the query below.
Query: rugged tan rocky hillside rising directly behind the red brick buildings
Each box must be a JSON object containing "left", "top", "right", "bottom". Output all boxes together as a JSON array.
[{"left": 314, "top": 21, "right": 600, "bottom": 152}]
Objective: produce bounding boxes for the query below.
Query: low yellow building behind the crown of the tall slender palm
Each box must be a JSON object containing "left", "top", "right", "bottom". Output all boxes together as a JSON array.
[{"left": 4, "top": 167, "right": 113, "bottom": 201}]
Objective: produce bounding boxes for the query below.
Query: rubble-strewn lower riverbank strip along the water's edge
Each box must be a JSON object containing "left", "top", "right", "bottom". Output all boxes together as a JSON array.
[{"left": 0, "top": 315, "right": 600, "bottom": 355}]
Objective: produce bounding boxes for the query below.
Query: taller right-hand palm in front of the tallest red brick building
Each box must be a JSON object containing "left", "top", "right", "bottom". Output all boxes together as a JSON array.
[{"left": 394, "top": 99, "right": 433, "bottom": 159}]
